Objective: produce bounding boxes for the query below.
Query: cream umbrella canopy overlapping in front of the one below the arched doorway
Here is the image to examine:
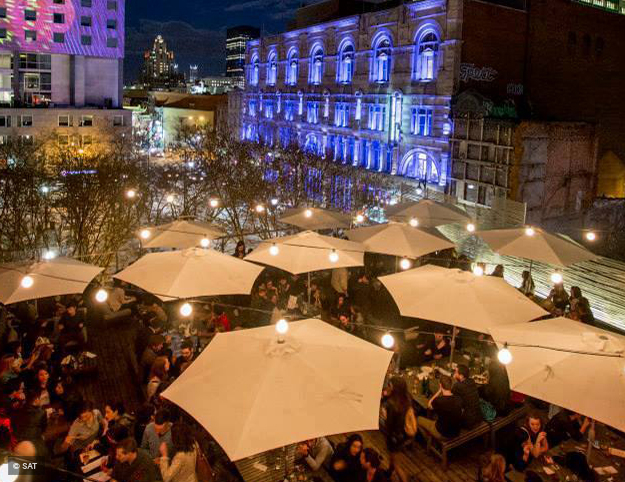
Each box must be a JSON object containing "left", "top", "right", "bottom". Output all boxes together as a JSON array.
[{"left": 346, "top": 222, "right": 455, "bottom": 258}]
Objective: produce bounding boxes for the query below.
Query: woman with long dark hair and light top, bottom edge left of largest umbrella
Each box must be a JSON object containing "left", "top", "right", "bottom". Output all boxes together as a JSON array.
[{"left": 159, "top": 423, "right": 197, "bottom": 482}]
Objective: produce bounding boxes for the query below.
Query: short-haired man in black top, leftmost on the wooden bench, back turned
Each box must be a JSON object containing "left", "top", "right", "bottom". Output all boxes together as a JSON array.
[{"left": 417, "top": 375, "right": 463, "bottom": 439}]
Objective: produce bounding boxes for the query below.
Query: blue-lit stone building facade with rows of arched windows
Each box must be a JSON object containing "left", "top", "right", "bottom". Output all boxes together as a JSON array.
[{"left": 240, "top": 0, "right": 461, "bottom": 192}]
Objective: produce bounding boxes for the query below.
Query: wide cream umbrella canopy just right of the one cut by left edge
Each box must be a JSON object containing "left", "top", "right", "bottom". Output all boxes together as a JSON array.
[{"left": 114, "top": 248, "right": 263, "bottom": 301}]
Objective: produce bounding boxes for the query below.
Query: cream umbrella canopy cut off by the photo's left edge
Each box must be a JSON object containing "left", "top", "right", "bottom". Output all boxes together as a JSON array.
[{"left": 0, "top": 258, "right": 104, "bottom": 305}]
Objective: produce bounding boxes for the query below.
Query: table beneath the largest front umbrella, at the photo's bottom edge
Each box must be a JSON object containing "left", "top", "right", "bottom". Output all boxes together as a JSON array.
[{"left": 234, "top": 444, "right": 334, "bottom": 482}]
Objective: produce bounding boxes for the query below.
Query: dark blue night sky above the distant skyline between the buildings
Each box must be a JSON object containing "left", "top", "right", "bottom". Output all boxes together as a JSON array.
[{"left": 125, "top": 0, "right": 304, "bottom": 84}]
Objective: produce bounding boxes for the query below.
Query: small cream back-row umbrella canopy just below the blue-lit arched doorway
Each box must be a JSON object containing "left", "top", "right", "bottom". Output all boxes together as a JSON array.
[{"left": 386, "top": 199, "right": 471, "bottom": 227}]
